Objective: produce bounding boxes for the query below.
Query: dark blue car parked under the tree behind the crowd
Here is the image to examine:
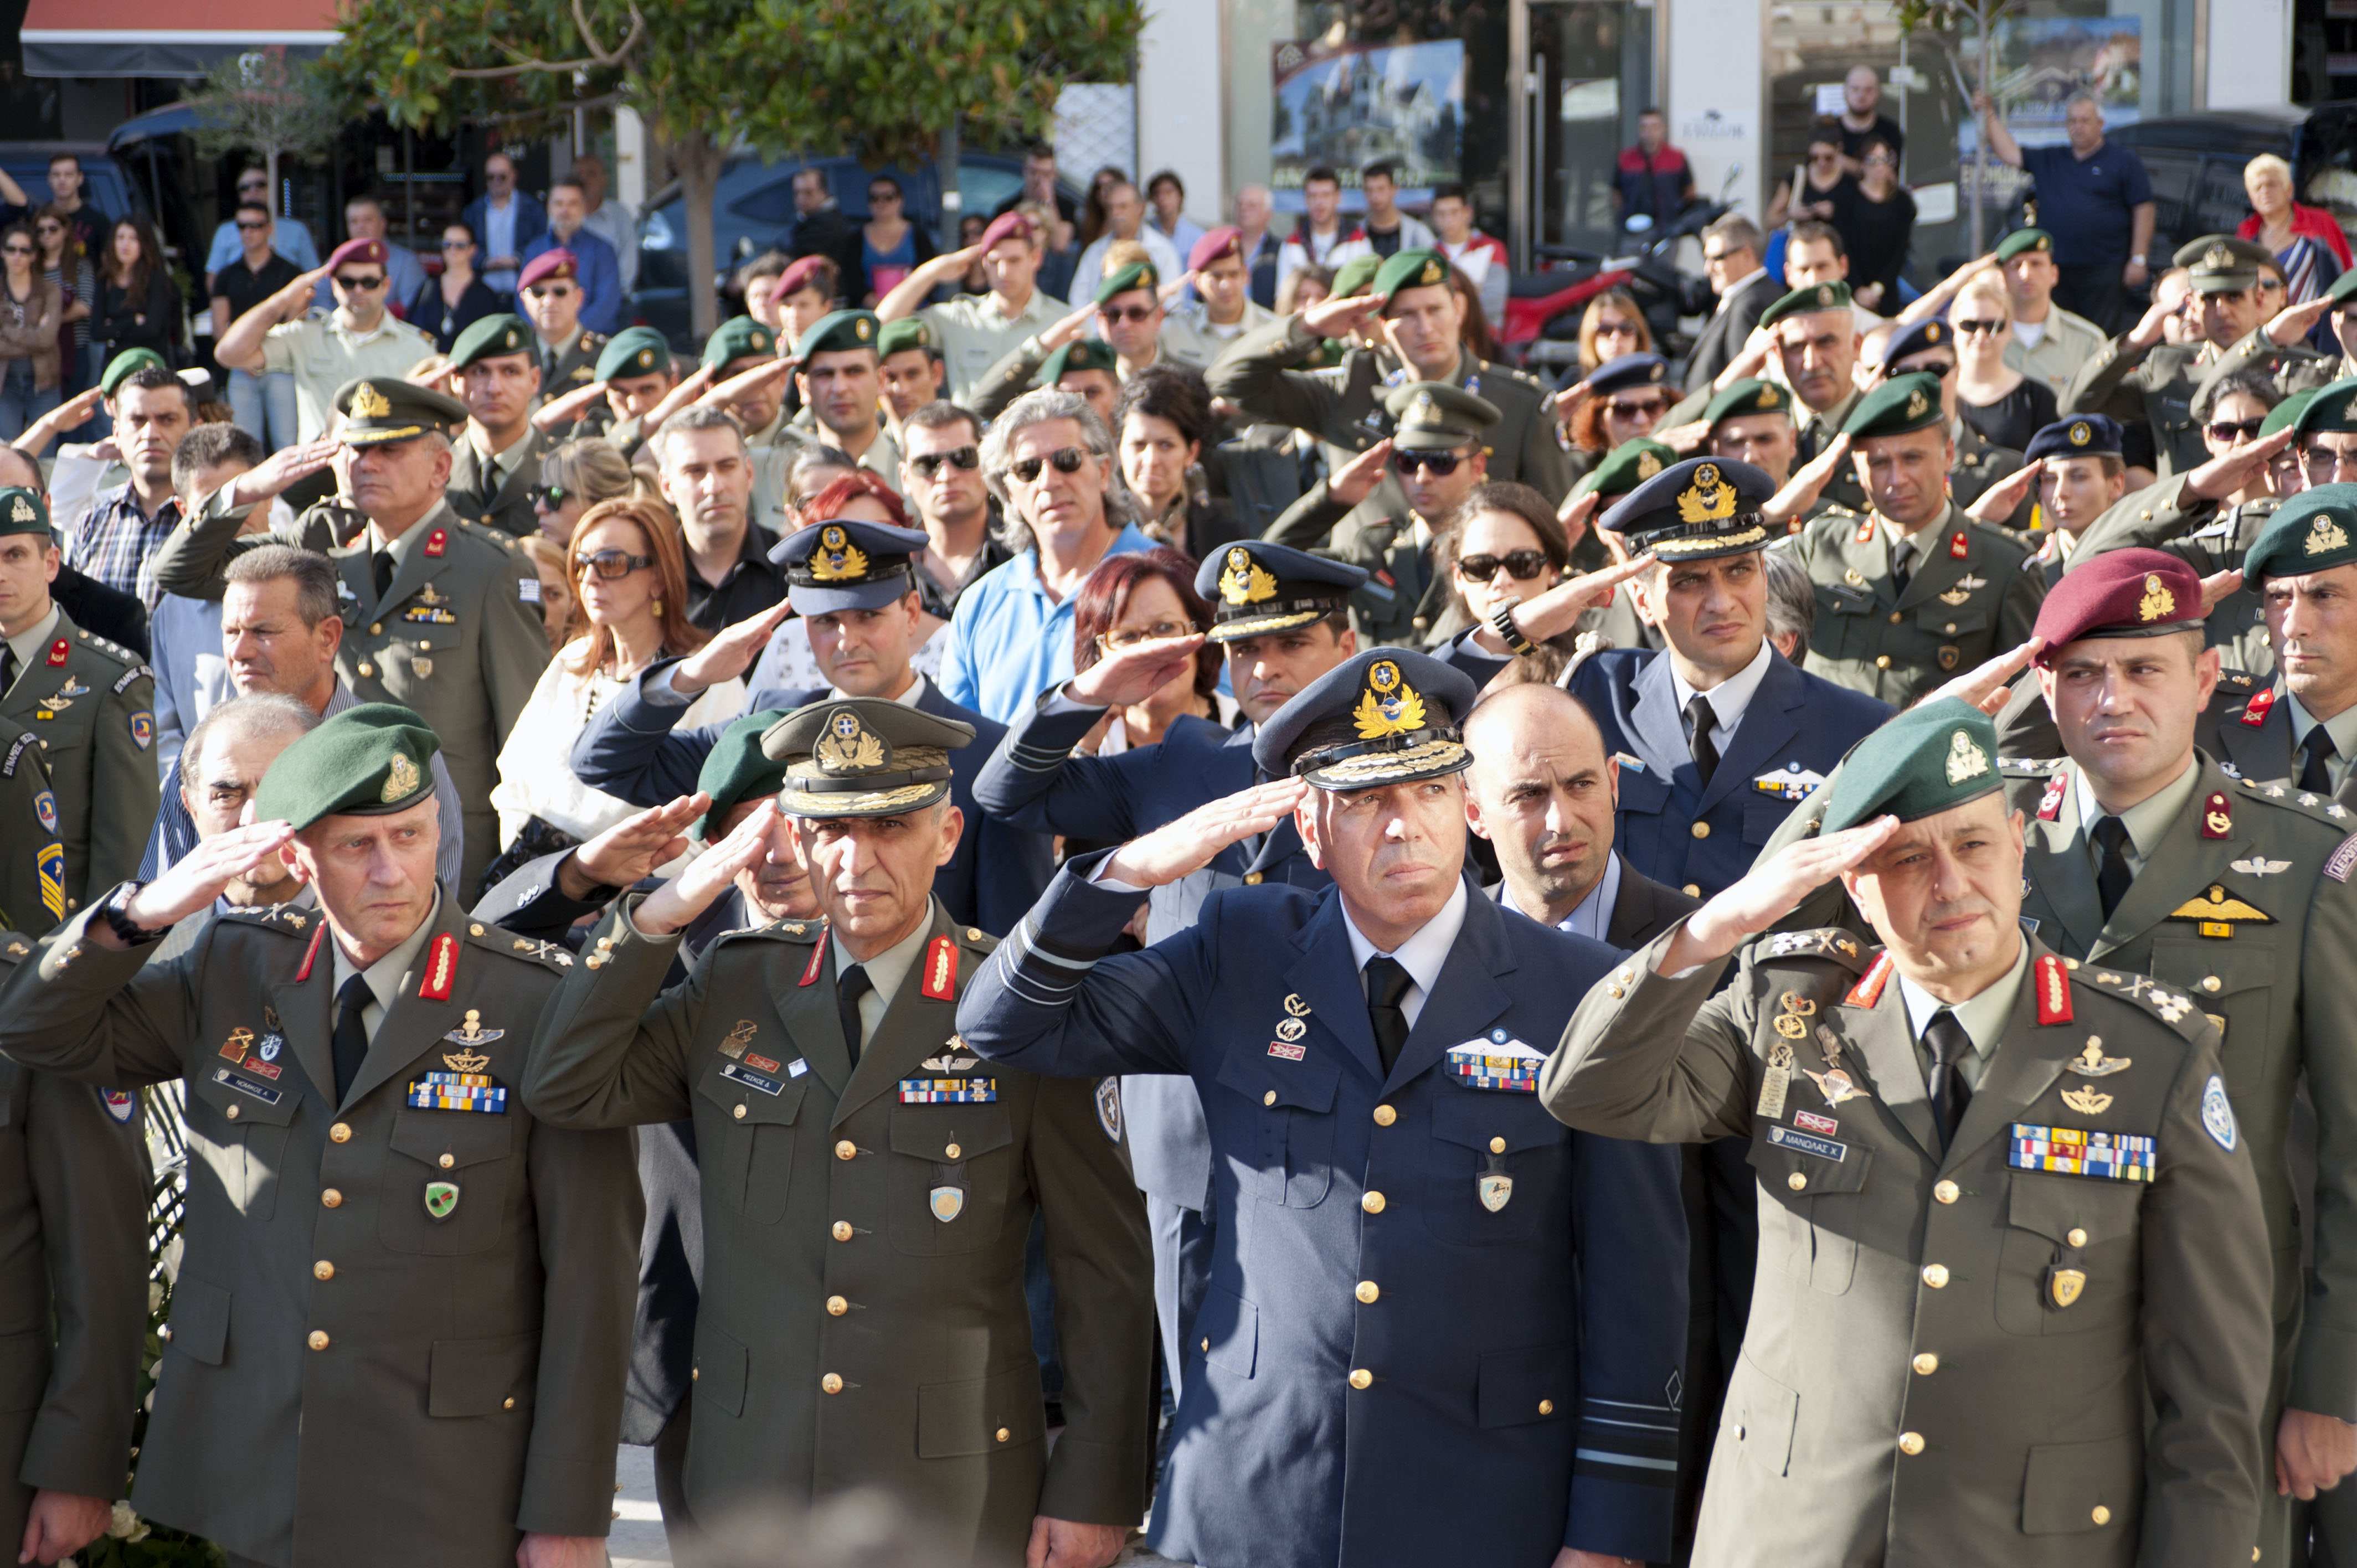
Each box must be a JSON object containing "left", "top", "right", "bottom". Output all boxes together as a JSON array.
[{"left": 627, "top": 153, "right": 1079, "bottom": 349}]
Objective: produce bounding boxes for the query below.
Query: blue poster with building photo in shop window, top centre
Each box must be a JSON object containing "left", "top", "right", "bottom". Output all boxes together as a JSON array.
[{"left": 1268, "top": 38, "right": 1466, "bottom": 212}]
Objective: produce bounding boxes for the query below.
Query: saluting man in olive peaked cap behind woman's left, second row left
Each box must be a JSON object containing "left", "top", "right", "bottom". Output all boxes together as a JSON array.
[{"left": 148, "top": 377, "right": 549, "bottom": 889}]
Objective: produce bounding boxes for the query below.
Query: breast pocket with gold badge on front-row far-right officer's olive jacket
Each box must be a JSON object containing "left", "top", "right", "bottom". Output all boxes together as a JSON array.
[{"left": 1996, "top": 1169, "right": 2147, "bottom": 1334}]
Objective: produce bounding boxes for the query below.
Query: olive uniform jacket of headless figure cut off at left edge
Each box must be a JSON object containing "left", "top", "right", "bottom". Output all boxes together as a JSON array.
[{"left": 0, "top": 929, "right": 153, "bottom": 1544}]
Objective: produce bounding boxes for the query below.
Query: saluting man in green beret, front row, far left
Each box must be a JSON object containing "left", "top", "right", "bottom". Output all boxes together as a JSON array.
[{"left": 0, "top": 703, "right": 639, "bottom": 1568}]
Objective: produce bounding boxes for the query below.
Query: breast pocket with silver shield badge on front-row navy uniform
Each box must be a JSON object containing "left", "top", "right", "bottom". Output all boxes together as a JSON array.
[{"left": 1424, "top": 1082, "right": 1572, "bottom": 1247}]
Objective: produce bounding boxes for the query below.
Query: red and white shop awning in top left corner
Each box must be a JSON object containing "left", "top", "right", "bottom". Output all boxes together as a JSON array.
[{"left": 24, "top": 0, "right": 339, "bottom": 75}]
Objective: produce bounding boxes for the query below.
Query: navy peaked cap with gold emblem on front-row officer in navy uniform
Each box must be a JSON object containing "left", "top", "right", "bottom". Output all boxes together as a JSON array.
[{"left": 1252, "top": 648, "right": 1480, "bottom": 790}]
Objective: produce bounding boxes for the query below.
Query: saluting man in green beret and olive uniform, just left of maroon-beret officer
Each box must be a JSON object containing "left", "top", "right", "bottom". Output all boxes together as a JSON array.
[{"left": 1789, "top": 375, "right": 2046, "bottom": 708}]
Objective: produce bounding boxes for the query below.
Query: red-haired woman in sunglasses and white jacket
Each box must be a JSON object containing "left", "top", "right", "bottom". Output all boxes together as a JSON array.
[{"left": 483, "top": 498, "right": 745, "bottom": 889}]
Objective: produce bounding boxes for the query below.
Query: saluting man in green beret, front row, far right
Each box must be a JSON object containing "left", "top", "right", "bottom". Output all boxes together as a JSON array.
[{"left": 1541, "top": 700, "right": 2279, "bottom": 1568}]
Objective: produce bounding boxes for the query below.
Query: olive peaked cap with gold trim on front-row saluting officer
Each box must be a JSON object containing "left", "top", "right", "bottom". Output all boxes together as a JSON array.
[{"left": 761, "top": 698, "right": 974, "bottom": 818}]
